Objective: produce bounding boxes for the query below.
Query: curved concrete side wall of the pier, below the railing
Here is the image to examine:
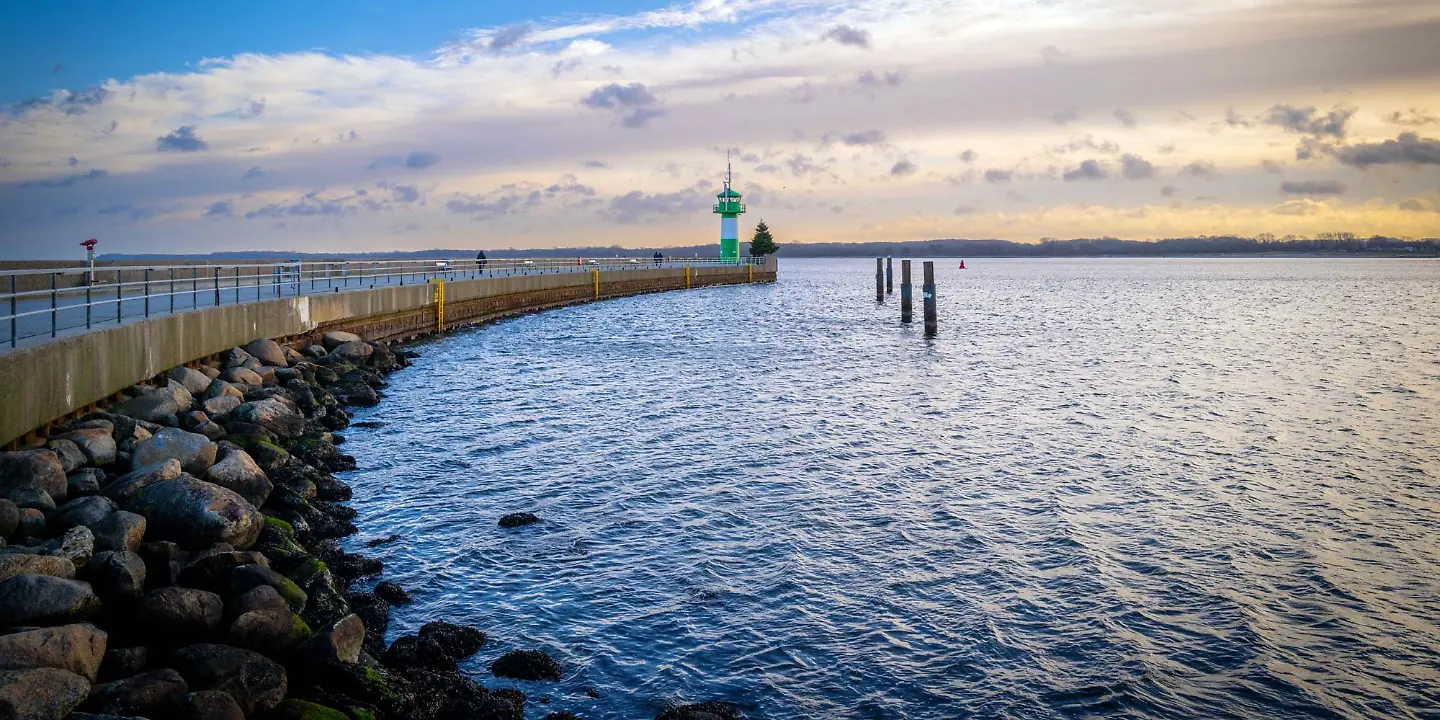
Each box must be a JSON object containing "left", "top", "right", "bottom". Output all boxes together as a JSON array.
[{"left": 0, "top": 256, "right": 776, "bottom": 446}]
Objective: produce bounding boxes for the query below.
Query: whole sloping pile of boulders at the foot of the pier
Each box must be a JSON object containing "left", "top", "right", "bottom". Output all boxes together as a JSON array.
[{"left": 0, "top": 333, "right": 587, "bottom": 720}]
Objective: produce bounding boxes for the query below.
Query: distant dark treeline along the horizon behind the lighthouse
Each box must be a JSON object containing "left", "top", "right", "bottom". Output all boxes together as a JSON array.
[{"left": 101, "top": 233, "right": 1440, "bottom": 262}]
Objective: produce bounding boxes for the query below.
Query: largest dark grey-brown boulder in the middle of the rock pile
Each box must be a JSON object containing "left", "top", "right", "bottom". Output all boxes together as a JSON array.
[{"left": 124, "top": 475, "right": 265, "bottom": 550}]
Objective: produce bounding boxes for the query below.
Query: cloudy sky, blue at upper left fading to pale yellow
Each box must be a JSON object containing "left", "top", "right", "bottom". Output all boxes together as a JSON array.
[{"left": 0, "top": 0, "right": 1440, "bottom": 259}]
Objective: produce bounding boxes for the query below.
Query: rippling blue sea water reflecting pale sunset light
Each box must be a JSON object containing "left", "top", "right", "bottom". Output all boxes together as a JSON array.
[{"left": 346, "top": 259, "right": 1440, "bottom": 719}]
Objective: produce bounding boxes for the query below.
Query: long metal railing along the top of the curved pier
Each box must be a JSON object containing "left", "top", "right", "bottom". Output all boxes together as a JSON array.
[{"left": 0, "top": 256, "right": 765, "bottom": 348}]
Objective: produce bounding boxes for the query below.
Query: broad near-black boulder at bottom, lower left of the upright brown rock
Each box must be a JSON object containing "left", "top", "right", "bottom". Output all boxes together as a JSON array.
[{"left": 171, "top": 644, "right": 287, "bottom": 717}]
